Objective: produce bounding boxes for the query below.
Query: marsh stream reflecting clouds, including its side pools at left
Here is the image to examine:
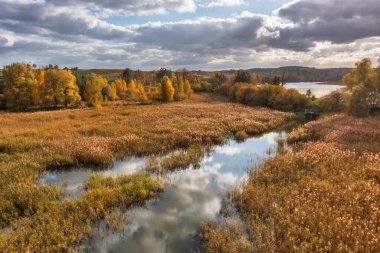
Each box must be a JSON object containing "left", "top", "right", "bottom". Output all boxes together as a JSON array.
[{"left": 40, "top": 131, "right": 287, "bottom": 253}]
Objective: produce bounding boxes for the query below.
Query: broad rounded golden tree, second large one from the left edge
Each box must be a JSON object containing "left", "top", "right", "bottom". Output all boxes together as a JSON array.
[{"left": 41, "top": 68, "right": 81, "bottom": 107}]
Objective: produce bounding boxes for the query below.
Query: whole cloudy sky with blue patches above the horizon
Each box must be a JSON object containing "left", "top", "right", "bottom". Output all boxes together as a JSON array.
[{"left": 0, "top": 0, "right": 380, "bottom": 70}]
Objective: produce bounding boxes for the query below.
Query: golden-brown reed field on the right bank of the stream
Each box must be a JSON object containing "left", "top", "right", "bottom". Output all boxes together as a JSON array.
[{"left": 202, "top": 115, "right": 380, "bottom": 252}]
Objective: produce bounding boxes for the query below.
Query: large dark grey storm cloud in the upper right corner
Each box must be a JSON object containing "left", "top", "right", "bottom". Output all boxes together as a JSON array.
[{"left": 269, "top": 0, "right": 380, "bottom": 51}]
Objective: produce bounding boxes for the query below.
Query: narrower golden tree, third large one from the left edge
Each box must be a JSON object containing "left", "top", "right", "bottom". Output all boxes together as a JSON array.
[{"left": 83, "top": 73, "right": 107, "bottom": 107}]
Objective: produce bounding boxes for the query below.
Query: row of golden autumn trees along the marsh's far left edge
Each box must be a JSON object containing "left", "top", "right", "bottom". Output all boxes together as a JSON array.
[{"left": 0, "top": 63, "right": 193, "bottom": 111}]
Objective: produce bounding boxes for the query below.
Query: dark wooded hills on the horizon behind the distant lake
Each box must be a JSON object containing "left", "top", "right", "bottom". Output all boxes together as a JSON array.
[{"left": 217, "top": 66, "right": 351, "bottom": 83}]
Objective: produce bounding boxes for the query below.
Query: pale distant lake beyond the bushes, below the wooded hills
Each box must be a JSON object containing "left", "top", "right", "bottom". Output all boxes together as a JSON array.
[{"left": 285, "top": 82, "right": 346, "bottom": 98}]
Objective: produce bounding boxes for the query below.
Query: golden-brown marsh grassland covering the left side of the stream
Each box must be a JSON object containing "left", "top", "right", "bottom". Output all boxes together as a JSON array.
[{"left": 0, "top": 95, "right": 294, "bottom": 252}]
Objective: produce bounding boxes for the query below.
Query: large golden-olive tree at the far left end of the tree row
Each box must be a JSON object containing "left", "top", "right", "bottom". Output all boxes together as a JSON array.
[{"left": 3, "top": 63, "right": 38, "bottom": 110}]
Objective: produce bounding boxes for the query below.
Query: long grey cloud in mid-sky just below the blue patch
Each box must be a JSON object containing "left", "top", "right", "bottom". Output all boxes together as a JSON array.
[{"left": 132, "top": 15, "right": 262, "bottom": 54}]
